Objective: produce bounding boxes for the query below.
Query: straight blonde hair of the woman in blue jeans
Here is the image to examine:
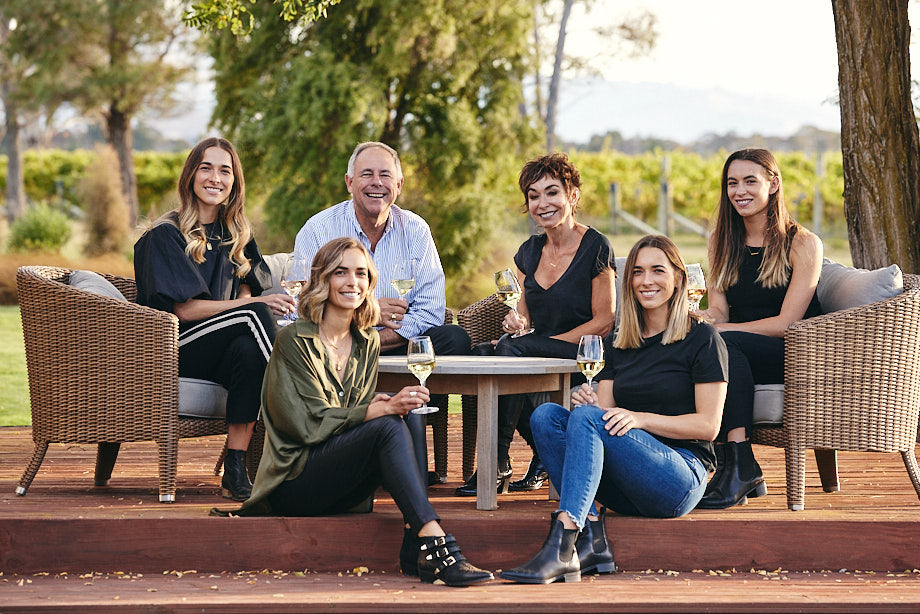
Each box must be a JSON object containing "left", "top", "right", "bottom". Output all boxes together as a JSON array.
[{"left": 613, "top": 235, "right": 691, "bottom": 350}]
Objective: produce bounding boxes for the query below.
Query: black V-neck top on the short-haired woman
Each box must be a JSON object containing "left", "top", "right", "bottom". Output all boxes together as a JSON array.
[{"left": 514, "top": 227, "right": 616, "bottom": 337}]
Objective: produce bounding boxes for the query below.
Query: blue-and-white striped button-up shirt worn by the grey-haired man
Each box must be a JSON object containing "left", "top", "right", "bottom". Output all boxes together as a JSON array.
[{"left": 294, "top": 200, "right": 447, "bottom": 339}]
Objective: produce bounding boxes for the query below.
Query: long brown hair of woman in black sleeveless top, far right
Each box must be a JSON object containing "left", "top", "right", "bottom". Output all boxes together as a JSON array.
[{"left": 709, "top": 149, "right": 801, "bottom": 292}]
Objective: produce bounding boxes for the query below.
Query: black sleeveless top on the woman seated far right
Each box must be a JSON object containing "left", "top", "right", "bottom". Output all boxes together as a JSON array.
[{"left": 725, "top": 246, "right": 821, "bottom": 322}]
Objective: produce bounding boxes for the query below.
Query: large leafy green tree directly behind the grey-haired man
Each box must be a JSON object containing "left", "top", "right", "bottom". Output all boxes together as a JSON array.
[{"left": 213, "top": 0, "right": 536, "bottom": 275}]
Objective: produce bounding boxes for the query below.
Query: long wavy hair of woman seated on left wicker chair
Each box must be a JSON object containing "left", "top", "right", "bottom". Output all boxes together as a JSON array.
[{"left": 169, "top": 137, "right": 252, "bottom": 278}]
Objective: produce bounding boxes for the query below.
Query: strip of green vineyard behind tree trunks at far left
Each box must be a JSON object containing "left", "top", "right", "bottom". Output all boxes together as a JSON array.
[{"left": 0, "top": 149, "right": 188, "bottom": 215}]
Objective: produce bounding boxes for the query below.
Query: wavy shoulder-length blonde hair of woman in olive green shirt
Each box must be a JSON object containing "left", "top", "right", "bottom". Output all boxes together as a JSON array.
[{"left": 297, "top": 237, "right": 380, "bottom": 330}]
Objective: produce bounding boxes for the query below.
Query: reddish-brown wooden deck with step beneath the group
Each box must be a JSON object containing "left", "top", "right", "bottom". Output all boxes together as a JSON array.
[{"left": 0, "top": 417, "right": 920, "bottom": 612}]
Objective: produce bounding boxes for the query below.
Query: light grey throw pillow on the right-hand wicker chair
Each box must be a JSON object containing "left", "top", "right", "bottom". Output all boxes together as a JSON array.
[{"left": 817, "top": 258, "right": 904, "bottom": 313}]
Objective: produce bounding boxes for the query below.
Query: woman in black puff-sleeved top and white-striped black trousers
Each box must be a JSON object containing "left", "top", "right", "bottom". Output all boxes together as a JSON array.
[{"left": 134, "top": 138, "right": 296, "bottom": 501}]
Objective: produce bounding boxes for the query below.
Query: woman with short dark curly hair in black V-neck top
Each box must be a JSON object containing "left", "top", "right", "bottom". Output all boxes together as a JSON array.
[{"left": 456, "top": 153, "right": 616, "bottom": 496}]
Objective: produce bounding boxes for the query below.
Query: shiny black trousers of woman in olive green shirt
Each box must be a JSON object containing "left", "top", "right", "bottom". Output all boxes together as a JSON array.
[{"left": 269, "top": 415, "right": 440, "bottom": 533}]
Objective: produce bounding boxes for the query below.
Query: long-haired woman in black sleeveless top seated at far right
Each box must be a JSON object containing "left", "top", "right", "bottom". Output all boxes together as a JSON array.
[{"left": 697, "top": 149, "right": 824, "bottom": 509}]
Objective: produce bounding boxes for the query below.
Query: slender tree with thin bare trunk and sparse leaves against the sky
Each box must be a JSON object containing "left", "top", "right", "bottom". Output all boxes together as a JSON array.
[{"left": 533, "top": 0, "right": 658, "bottom": 151}]
